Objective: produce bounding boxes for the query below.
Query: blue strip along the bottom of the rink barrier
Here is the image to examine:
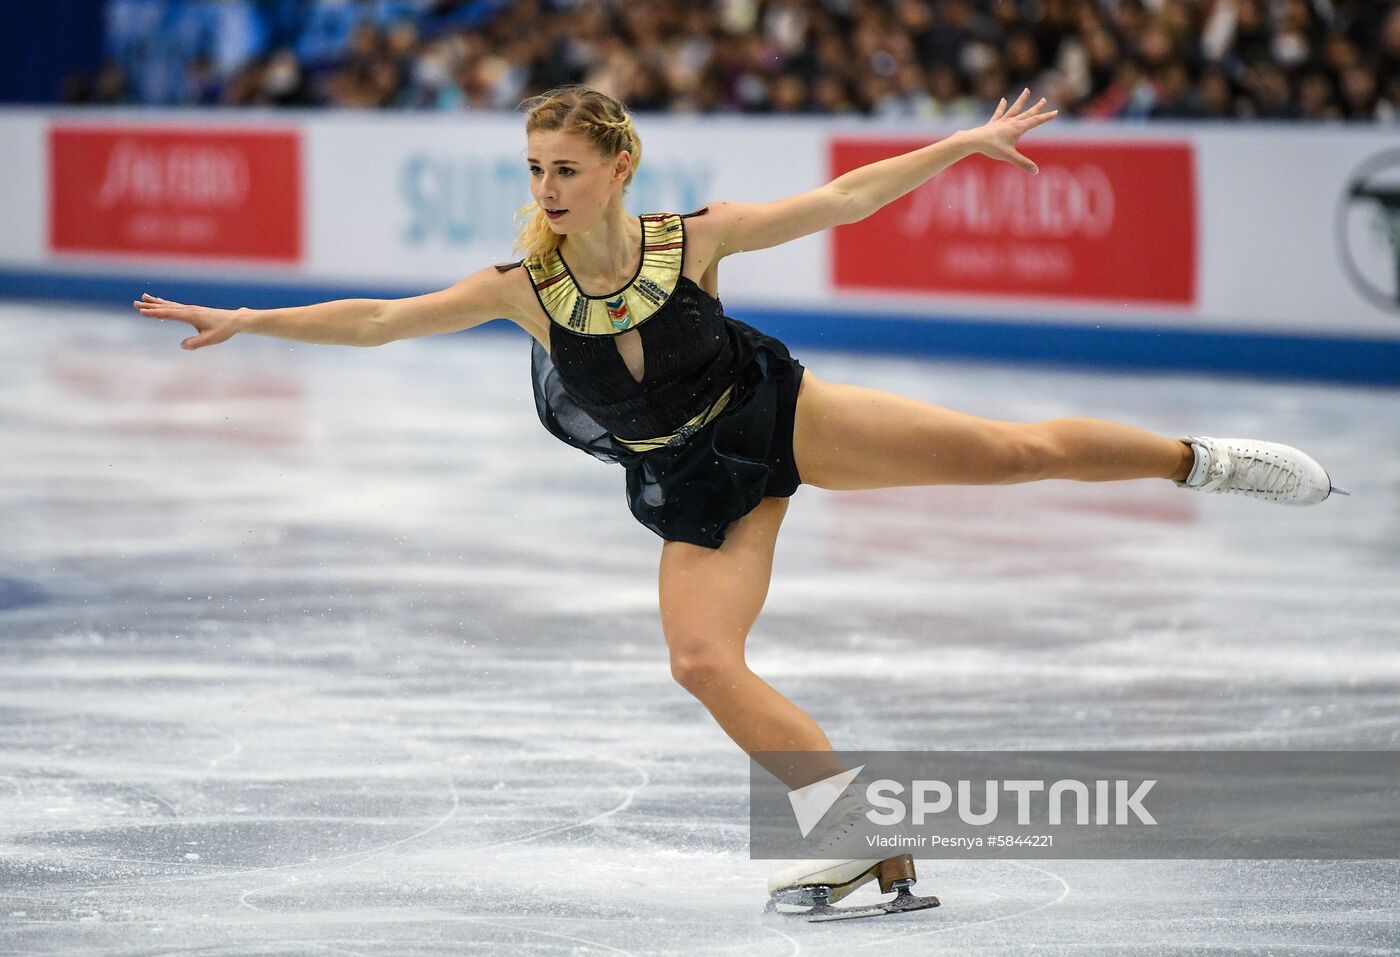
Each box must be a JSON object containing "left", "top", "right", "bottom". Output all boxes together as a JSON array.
[{"left": 0, "top": 270, "right": 1400, "bottom": 386}]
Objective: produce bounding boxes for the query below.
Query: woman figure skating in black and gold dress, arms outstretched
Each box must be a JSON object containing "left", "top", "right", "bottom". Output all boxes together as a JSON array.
[{"left": 134, "top": 87, "right": 1331, "bottom": 917}]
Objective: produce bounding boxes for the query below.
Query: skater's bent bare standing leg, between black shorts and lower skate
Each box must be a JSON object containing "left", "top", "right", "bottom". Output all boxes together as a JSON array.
[{"left": 659, "top": 498, "right": 843, "bottom": 788}]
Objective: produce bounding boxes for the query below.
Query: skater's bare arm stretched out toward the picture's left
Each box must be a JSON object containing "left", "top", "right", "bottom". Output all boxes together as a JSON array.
[{"left": 132, "top": 267, "right": 517, "bottom": 350}]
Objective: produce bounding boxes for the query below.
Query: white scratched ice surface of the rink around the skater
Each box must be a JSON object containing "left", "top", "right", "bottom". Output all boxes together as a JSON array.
[{"left": 0, "top": 300, "right": 1400, "bottom": 957}]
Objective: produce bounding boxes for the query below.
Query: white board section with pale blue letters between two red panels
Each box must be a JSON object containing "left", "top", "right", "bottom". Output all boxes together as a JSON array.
[{"left": 307, "top": 115, "right": 825, "bottom": 301}]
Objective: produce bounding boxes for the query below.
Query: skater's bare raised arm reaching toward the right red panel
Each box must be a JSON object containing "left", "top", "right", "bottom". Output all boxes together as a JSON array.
[{"left": 699, "top": 90, "right": 1060, "bottom": 259}]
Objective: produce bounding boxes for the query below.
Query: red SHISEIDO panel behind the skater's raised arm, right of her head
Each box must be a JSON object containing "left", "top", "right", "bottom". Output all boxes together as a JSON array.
[{"left": 832, "top": 139, "right": 1196, "bottom": 305}]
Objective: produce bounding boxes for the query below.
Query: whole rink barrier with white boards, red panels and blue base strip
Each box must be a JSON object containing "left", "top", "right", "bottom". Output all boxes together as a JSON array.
[{"left": 10, "top": 108, "right": 1400, "bottom": 385}]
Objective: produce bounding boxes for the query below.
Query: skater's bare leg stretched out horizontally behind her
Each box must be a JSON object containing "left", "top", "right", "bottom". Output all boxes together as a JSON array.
[{"left": 792, "top": 371, "right": 1194, "bottom": 490}]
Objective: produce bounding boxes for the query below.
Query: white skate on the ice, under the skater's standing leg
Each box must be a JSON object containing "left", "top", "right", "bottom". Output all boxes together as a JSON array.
[{"left": 764, "top": 793, "right": 938, "bottom": 921}]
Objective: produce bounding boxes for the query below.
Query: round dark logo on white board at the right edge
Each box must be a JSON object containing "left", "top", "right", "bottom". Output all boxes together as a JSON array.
[{"left": 1337, "top": 150, "right": 1400, "bottom": 312}]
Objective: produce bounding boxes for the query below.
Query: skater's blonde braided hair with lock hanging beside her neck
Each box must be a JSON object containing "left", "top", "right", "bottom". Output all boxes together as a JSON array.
[{"left": 515, "top": 84, "right": 641, "bottom": 259}]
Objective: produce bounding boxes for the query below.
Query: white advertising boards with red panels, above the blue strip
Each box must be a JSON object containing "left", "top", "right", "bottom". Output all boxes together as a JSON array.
[{"left": 0, "top": 109, "right": 1400, "bottom": 340}]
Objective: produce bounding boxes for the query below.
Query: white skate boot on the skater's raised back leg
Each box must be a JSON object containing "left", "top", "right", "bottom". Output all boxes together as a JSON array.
[{"left": 1176, "top": 435, "right": 1351, "bottom": 505}]
